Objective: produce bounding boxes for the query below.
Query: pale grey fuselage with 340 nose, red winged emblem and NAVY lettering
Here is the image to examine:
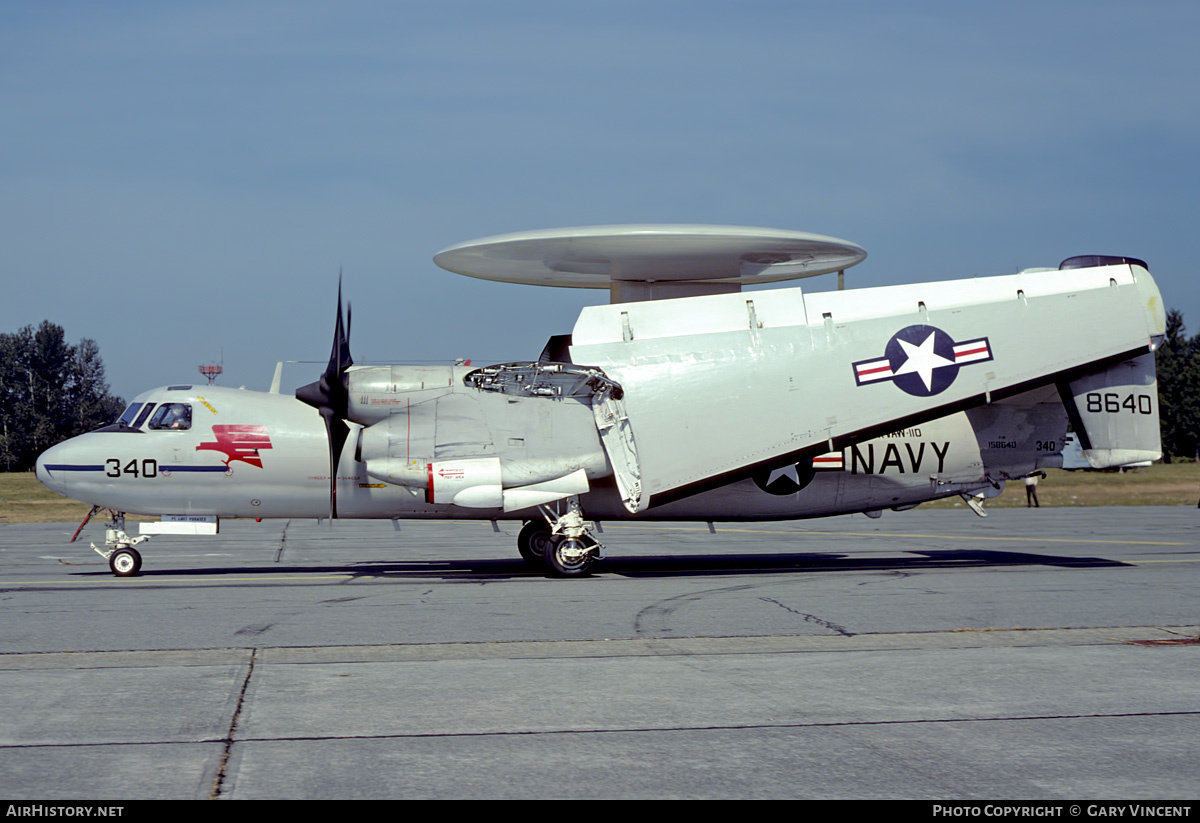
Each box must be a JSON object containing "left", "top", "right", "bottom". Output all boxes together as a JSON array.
[{"left": 30, "top": 386, "right": 1066, "bottom": 521}]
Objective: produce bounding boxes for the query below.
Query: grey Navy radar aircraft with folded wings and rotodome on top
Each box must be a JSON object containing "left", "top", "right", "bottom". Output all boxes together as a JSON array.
[{"left": 37, "top": 224, "right": 1165, "bottom": 576}]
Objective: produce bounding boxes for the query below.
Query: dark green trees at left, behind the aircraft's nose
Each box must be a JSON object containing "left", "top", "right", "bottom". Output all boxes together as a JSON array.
[{"left": 0, "top": 320, "right": 125, "bottom": 471}]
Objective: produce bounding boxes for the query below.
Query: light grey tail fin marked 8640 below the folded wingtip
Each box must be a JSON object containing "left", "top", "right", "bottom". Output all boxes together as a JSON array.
[{"left": 1058, "top": 354, "right": 1163, "bottom": 469}]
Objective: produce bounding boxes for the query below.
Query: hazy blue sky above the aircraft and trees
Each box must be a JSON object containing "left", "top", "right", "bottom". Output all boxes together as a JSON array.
[{"left": 0, "top": 0, "right": 1200, "bottom": 398}]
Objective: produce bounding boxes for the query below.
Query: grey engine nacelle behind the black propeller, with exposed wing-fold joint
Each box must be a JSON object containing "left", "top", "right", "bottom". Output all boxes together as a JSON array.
[{"left": 348, "top": 364, "right": 619, "bottom": 511}]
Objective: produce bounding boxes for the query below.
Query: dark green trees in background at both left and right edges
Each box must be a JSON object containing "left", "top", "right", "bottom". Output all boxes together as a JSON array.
[{"left": 0, "top": 310, "right": 1200, "bottom": 471}]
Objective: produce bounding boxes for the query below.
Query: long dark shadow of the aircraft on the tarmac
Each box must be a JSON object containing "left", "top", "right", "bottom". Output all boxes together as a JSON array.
[{"left": 70, "top": 549, "right": 1130, "bottom": 583}]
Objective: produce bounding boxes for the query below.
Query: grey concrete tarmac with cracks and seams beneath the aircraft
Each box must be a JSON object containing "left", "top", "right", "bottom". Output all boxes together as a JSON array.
[{"left": 0, "top": 507, "right": 1200, "bottom": 801}]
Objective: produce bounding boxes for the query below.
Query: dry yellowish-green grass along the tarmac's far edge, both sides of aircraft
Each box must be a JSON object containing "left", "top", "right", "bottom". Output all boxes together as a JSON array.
[{"left": 0, "top": 463, "right": 1200, "bottom": 523}]
